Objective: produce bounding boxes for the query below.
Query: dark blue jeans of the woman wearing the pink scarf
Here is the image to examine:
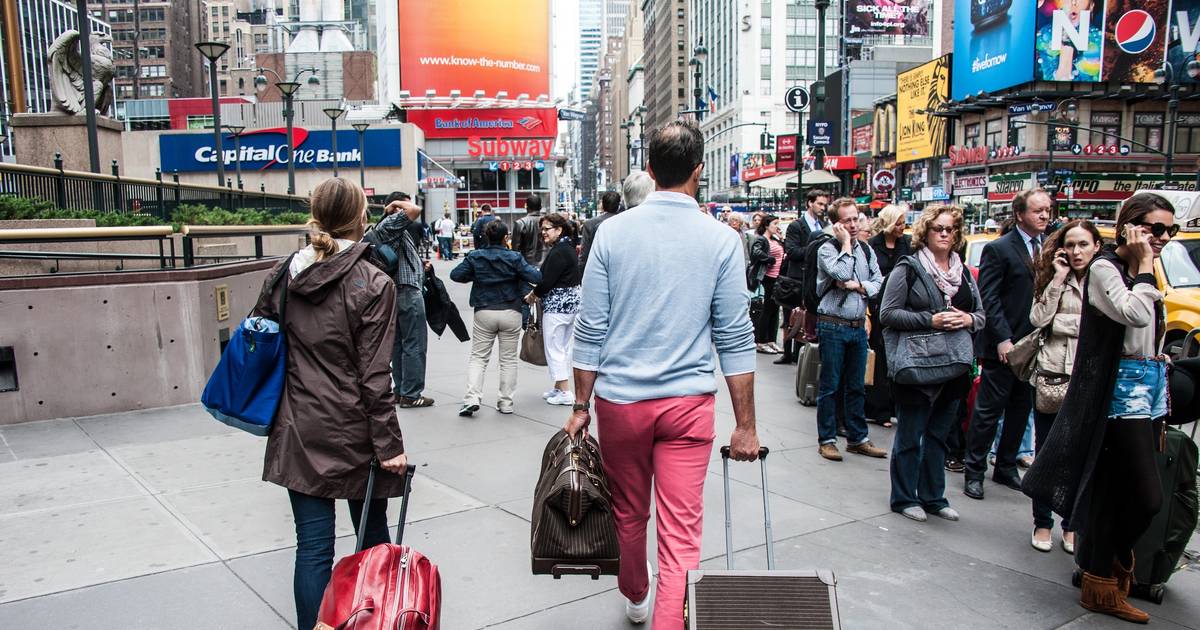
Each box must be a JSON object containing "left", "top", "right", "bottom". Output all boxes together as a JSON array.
[{"left": 890, "top": 390, "right": 959, "bottom": 512}]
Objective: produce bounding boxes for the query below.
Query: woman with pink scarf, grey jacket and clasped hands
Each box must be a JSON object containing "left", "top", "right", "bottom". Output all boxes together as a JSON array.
[{"left": 880, "top": 205, "right": 985, "bottom": 521}]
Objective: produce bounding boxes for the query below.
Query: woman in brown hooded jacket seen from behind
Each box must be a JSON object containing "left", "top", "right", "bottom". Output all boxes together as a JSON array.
[{"left": 254, "top": 178, "right": 408, "bottom": 628}]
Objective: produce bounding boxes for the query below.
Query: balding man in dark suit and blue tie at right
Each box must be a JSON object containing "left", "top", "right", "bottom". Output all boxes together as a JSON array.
[{"left": 962, "top": 188, "right": 1052, "bottom": 499}]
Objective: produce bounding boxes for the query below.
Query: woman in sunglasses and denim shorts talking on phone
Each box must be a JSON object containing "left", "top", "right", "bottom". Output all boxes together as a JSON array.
[{"left": 1022, "top": 193, "right": 1180, "bottom": 623}]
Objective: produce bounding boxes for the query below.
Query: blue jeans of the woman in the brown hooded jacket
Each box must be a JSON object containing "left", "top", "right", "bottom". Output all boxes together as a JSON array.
[{"left": 288, "top": 490, "right": 389, "bottom": 628}]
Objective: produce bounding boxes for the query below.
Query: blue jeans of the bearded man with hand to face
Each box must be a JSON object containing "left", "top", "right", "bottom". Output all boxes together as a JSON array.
[{"left": 817, "top": 322, "right": 868, "bottom": 445}]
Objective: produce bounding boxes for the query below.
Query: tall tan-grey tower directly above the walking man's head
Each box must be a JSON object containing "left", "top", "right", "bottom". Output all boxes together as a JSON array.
[{"left": 642, "top": 0, "right": 691, "bottom": 130}]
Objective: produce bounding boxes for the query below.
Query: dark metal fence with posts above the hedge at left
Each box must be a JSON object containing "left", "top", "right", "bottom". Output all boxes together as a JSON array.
[{"left": 0, "top": 154, "right": 308, "bottom": 221}]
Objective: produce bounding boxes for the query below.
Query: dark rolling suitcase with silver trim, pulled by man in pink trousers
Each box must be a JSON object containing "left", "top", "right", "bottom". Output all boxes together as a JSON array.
[{"left": 683, "top": 446, "right": 841, "bottom": 630}]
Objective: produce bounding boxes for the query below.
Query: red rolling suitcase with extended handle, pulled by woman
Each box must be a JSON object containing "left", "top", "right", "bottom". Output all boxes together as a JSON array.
[{"left": 316, "top": 461, "right": 442, "bottom": 630}]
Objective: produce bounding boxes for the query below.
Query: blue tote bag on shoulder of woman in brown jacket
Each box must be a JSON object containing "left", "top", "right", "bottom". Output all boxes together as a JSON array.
[{"left": 200, "top": 254, "right": 295, "bottom": 436}]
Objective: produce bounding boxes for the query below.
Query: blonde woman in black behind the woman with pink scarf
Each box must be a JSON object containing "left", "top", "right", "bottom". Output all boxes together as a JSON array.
[{"left": 865, "top": 204, "right": 912, "bottom": 427}]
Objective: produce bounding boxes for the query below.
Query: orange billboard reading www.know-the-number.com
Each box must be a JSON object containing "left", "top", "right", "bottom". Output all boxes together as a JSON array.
[{"left": 397, "top": 0, "right": 550, "bottom": 98}]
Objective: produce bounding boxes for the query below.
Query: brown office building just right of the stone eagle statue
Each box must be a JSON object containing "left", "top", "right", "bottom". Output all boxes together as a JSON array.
[{"left": 88, "top": 0, "right": 201, "bottom": 101}]
